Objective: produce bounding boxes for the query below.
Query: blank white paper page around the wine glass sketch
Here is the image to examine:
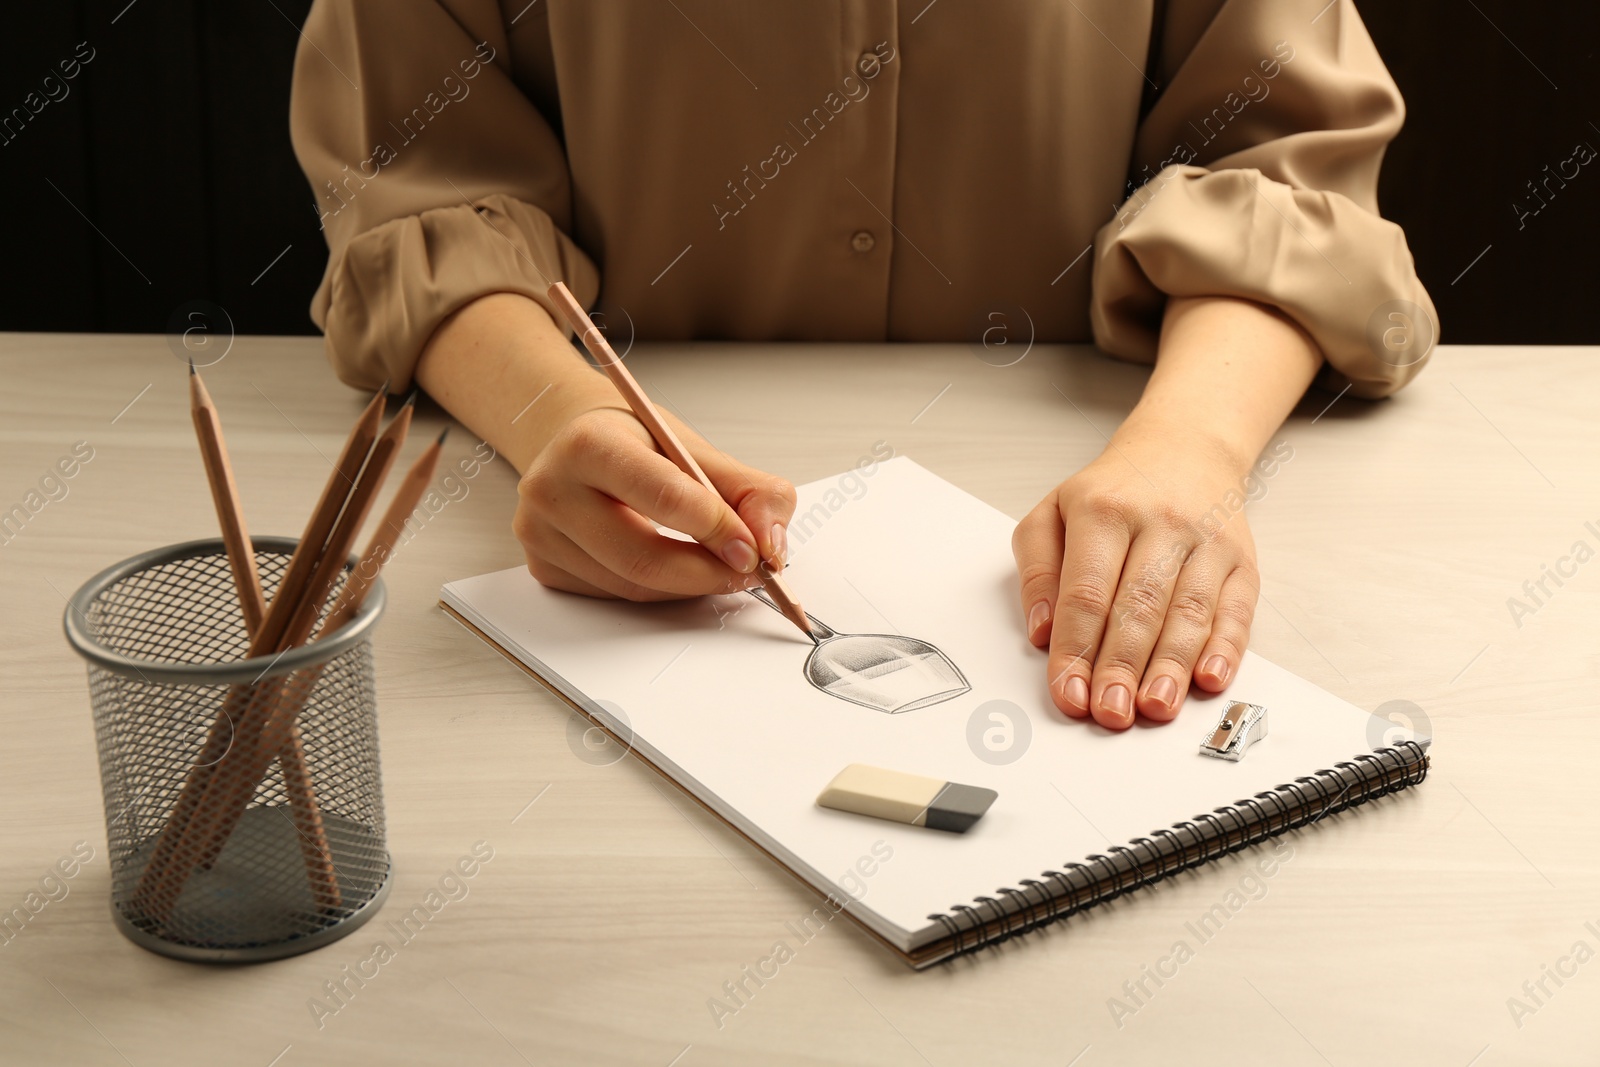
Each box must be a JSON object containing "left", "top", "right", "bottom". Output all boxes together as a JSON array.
[{"left": 445, "top": 458, "right": 1408, "bottom": 950}]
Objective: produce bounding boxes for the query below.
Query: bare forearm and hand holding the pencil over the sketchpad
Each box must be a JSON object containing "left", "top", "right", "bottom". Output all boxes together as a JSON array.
[{"left": 416, "top": 293, "right": 795, "bottom": 600}]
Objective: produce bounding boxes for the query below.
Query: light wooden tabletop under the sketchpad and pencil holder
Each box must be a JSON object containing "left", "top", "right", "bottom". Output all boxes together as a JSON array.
[{"left": 0, "top": 336, "right": 1600, "bottom": 1067}]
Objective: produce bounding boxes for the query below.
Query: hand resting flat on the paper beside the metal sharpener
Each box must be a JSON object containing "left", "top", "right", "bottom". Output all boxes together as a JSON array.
[{"left": 1011, "top": 413, "right": 1259, "bottom": 729}]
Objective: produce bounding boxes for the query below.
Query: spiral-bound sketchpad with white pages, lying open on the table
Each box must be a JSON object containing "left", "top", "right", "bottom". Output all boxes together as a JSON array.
[{"left": 442, "top": 458, "right": 1427, "bottom": 968}]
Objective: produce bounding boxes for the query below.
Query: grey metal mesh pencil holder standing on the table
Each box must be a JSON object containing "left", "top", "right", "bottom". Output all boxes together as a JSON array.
[{"left": 66, "top": 537, "right": 390, "bottom": 961}]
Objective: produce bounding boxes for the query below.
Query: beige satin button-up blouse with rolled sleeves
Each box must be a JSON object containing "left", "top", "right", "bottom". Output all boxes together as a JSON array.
[{"left": 291, "top": 0, "right": 1437, "bottom": 397}]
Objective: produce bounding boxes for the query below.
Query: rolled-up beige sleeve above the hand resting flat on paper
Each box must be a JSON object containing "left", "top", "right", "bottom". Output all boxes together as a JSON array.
[{"left": 1090, "top": 0, "right": 1438, "bottom": 397}]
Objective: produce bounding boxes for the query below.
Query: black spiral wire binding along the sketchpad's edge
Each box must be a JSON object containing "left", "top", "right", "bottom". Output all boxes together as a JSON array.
[{"left": 920, "top": 741, "right": 1429, "bottom": 965}]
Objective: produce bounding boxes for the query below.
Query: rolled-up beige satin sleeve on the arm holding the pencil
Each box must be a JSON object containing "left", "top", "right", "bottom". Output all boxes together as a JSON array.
[{"left": 290, "top": 0, "right": 600, "bottom": 390}]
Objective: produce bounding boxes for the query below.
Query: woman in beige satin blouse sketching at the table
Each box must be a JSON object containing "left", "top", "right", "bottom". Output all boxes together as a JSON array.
[{"left": 293, "top": 0, "right": 1437, "bottom": 728}]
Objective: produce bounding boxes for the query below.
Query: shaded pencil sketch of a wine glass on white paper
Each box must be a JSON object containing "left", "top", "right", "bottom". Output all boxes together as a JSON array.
[{"left": 749, "top": 589, "right": 971, "bottom": 715}]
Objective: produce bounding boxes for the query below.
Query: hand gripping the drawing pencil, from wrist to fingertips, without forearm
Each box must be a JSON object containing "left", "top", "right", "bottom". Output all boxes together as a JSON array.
[{"left": 512, "top": 406, "right": 795, "bottom": 600}]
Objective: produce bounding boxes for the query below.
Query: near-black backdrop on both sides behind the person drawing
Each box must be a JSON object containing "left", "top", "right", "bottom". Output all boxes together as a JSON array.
[{"left": 0, "top": 0, "right": 1600, "bottom": 344}]
